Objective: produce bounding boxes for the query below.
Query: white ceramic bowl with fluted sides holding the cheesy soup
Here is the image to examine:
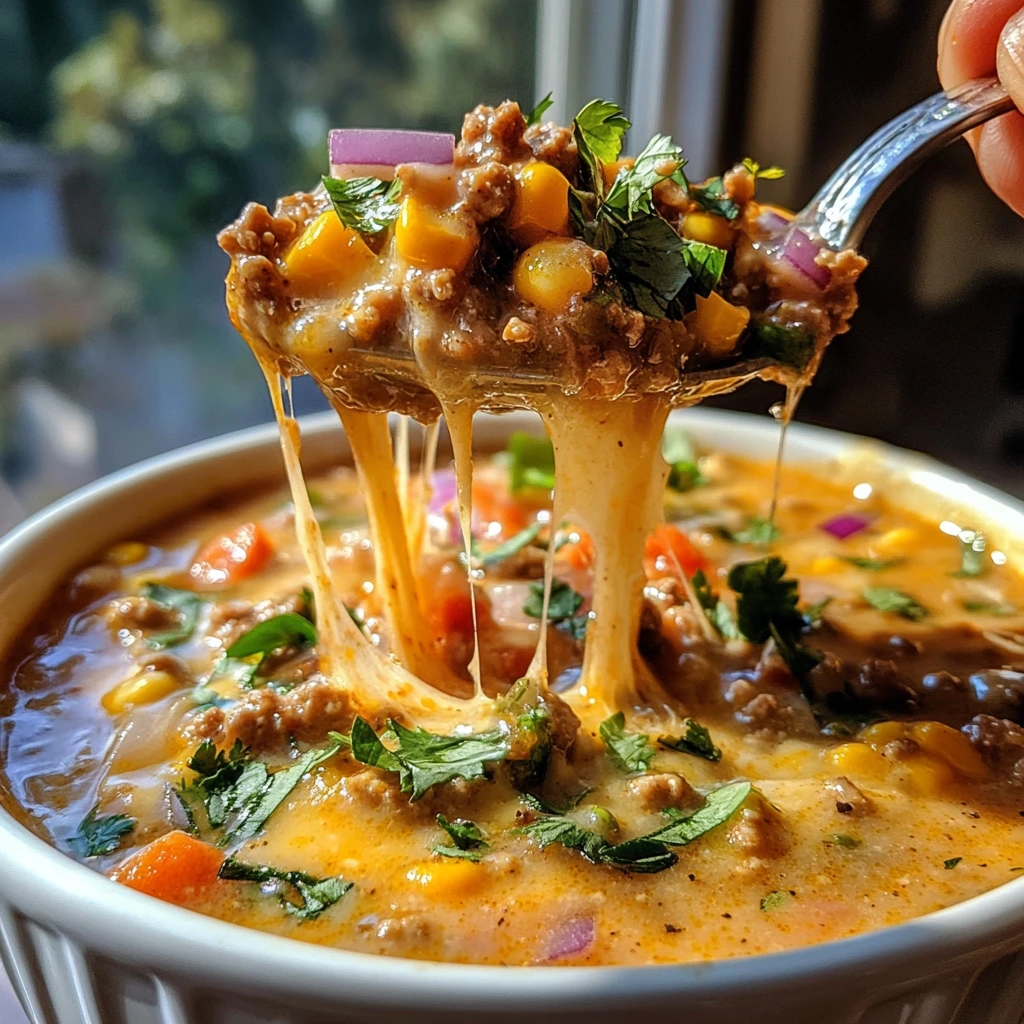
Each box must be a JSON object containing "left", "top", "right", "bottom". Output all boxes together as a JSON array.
[{"left": 0, "top": 410, "right": 1024, "bottom": 1024}]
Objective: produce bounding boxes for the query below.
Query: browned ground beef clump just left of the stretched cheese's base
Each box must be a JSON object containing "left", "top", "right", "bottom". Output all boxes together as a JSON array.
[{"left": 184, "top": 677, "right": 357, "bottom": 752}]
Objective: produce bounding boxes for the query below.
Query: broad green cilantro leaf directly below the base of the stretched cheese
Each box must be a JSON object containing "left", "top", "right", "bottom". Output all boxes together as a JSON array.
[{"left": 352, "top": 718, "right": 509, "bottom": 801}]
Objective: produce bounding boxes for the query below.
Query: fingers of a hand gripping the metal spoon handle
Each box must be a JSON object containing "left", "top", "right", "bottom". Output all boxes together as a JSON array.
[{"left": 939, "top": 0, "right": 1024, "bottom": 216}]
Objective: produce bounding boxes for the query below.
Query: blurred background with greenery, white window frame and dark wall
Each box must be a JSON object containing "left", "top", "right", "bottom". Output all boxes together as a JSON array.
[{"left": 0, "top": 0, "right": 1024, "bottom": 529}]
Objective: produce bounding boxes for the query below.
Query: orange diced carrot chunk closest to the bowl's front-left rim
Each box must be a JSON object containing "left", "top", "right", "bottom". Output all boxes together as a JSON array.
[{"left": 110, "top": 831, "right": 224, "bottom": 906}]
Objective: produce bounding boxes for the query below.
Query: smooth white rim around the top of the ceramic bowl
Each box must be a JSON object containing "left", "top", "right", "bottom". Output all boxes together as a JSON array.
[{"left": 0, "top": 409, "right": 1024, "bottom": 1012}]
